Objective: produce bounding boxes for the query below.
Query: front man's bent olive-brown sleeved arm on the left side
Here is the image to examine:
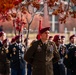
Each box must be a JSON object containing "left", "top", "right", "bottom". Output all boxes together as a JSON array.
[{"left": 24, "top": 43, "right": 36, "bottom": 64}]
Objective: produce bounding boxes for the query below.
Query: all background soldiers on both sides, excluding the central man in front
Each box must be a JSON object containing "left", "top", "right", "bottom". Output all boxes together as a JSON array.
[{"left": 0, "top": 28, "right": 76, "bottom": 75}]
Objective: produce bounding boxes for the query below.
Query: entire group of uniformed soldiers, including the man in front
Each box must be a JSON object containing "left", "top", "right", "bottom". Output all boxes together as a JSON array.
[{"left": 0, "top": 27, "right": 76, "bottom": 75}]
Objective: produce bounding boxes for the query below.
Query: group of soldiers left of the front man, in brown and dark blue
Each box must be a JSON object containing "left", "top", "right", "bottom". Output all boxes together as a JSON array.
[{"left": 0, "top": 31, "right": 26, "bottom": 75}]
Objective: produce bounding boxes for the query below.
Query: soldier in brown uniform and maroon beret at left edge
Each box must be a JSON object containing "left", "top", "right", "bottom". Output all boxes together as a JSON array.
[{"left": 0, "top": 39, "right": 10, "bottom": 75}]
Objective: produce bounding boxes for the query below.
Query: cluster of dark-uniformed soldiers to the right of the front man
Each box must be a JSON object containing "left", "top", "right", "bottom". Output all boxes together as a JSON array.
[{"left": 36, "top": 34, "right": 76, "bottom": 75}]
